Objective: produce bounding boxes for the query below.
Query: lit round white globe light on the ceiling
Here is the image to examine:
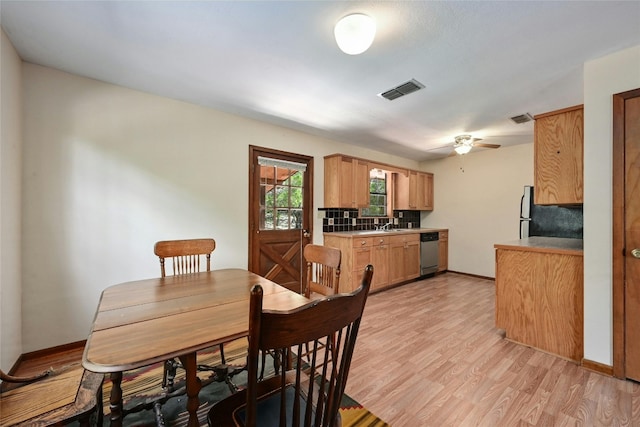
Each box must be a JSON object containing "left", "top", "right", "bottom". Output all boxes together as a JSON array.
[{"left": 333, "top": 13, "right": 376, "bottom": 55}]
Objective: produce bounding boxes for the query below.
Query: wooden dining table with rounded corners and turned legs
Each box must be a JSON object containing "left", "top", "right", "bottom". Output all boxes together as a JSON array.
[{"left": 82, "top": 268, "right": 309, "bottom": 426}]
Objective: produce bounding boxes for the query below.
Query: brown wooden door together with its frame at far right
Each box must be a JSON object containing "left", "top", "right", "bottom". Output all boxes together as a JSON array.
[{"left": 612, "top": 89, "right": 640, "bottom": 381}]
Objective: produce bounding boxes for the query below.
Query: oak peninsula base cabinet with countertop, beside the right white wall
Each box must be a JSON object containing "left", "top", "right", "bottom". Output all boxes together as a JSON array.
[{"left": 494, "top": 237, "right": 584, "bottom": 362}]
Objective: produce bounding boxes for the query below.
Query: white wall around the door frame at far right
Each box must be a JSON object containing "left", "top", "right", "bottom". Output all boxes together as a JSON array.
[{"left": 584, "top": 46, "right": 640, "bottom": 366}]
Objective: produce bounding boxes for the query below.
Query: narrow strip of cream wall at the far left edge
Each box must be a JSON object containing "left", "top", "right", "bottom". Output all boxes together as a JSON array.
[{"left": 0, "top": 29, "right": 22, "bottom": 371}]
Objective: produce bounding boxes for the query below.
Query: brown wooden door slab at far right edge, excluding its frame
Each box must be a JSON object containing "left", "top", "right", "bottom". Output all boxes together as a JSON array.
[{"left": 624, "top": 97, "right": 640, "bottom": 381}]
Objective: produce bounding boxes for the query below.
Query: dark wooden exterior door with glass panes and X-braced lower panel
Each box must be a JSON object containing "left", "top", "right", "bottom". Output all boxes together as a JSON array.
[{"left": 249, "top": 146, "right": 313, "bottom": 293}]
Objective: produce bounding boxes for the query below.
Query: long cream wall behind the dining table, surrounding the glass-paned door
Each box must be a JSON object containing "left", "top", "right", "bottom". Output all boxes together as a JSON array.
[{"left": 22, "top": 63, "right": 418, "bottom": 352}]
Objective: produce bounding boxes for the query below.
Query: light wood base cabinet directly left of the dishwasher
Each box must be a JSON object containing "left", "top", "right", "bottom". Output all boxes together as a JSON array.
[{"left": 388, "top": 233, "right": 420, "bottom": 285}]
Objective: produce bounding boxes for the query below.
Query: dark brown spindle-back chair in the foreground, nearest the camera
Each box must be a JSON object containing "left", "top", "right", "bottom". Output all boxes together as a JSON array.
[{"left": 207, "top": 265, "right": 373, "bottom": 427}]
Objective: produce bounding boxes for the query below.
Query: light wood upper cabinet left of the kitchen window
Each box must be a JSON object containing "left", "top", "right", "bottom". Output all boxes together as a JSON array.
[{"left": 324, "top": 154, "right": 369, "bottom": 209}]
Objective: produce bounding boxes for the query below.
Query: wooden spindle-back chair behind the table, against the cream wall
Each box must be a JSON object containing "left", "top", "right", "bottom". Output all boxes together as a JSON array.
[{"left": 153, "top": 239, "right": 236, "bottom": 391}]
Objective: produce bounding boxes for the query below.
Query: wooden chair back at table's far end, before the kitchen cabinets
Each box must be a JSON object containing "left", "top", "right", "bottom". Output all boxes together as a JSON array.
[{"left": 303, "top": 244, "right": 342, "bottom": 298}]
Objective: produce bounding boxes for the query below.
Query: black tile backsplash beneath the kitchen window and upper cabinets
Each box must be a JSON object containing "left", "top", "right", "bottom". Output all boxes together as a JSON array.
[{"left": 318, "top": 208, "right": 420, "bottom": 233}]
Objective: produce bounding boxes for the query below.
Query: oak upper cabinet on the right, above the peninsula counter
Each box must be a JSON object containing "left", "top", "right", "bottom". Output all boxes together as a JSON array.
[{"left": 533, "top": 105, "right": 584, "bottom": 205}]
